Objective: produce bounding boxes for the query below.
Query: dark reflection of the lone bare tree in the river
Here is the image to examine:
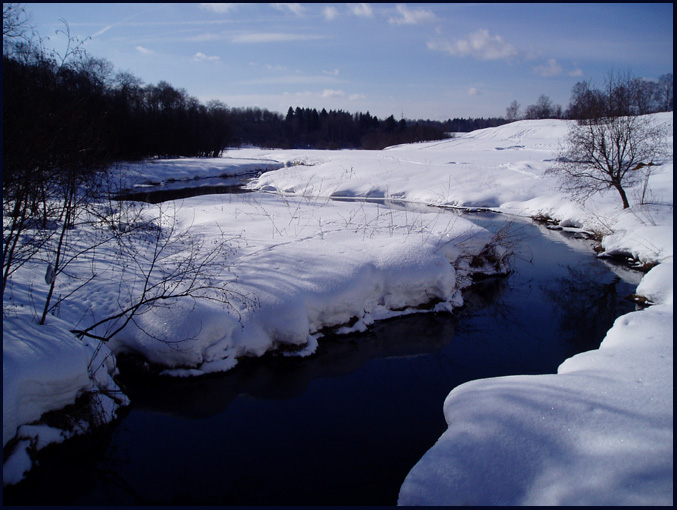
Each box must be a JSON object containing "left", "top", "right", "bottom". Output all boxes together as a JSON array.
[{"left": 542, "top": 263, "right": 633, "bottom": 352}]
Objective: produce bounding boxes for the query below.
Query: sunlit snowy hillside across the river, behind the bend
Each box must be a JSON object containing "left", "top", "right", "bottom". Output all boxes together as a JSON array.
[{"left": 239, "top": 112, "right": 673, "bottom": 255}]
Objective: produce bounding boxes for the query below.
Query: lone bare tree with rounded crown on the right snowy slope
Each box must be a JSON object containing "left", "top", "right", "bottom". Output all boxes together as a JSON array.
[{"left": 548, "top": 116, "right": 669, "bottom": 209}]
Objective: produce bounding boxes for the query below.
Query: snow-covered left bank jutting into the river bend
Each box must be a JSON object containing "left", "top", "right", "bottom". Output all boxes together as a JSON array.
[{"left": 3, "top": 193, "right": 506, "bottom": 483}]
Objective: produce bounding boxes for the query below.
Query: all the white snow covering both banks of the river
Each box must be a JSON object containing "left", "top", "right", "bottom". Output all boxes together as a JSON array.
[{"left": 3, "top": 113, "right": 673, "bottom": 505}]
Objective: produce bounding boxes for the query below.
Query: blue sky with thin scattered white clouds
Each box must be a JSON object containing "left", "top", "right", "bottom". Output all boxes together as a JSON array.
[{"left": 26, "top": 3, "right": 673, "bottom": 120}]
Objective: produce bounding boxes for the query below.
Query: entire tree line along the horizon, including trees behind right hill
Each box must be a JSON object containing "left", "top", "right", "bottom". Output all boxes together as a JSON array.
[{"left": 3, "top": 4, "right": 672, "bottom": 171}]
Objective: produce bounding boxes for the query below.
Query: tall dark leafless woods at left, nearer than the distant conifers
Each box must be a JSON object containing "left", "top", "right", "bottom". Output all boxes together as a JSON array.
[{"left": 3, "top": 48, "right": 231, "bottom": 163}]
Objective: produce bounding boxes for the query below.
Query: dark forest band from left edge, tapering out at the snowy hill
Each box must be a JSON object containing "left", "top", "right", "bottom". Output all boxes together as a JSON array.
[{"left": 3, "top": 43, "right": 506, "bottom": 160}]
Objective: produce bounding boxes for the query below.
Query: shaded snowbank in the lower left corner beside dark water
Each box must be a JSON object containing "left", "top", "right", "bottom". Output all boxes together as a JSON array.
[{"left": 2, "top": 310, "right": 129, "bottom": 484}]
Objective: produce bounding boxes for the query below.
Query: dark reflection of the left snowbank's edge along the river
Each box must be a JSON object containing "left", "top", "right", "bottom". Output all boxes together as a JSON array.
[{"left": 116, "top": 270, "right": 509, "bottom": 419}]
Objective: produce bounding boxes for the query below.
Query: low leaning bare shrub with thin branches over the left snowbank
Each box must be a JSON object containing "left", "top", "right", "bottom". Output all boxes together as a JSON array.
[{"left": 72, "top": 198, "right": 257, "bottom": 343}]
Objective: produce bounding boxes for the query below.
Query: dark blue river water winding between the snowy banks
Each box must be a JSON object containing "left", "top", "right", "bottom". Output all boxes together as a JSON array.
[{"left": 4, "top": 202, "right": 639, "bottom": 505}]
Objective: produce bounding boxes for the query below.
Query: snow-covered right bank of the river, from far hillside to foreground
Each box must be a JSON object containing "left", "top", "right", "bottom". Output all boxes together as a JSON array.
[{"left": 227, "top": 113, "right": 674, "bottom": 505}]
